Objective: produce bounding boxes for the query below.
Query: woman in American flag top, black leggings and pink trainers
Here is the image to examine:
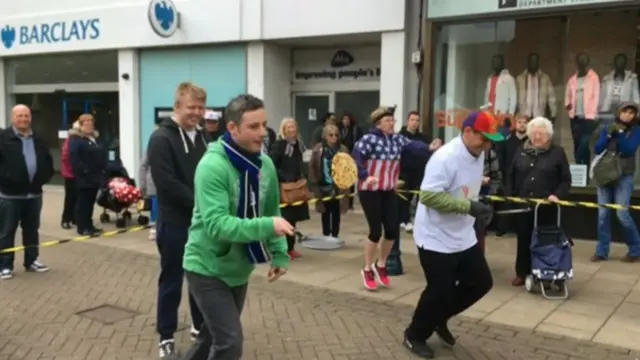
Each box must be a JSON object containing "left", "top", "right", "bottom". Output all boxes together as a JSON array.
[{"left": 353, "top": 107, "right": 433, "bottom": 291}]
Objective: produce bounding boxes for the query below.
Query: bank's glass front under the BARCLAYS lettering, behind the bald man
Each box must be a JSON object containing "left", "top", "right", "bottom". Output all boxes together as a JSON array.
[{"left": 5, "top": 51, "right": 119, "bottom": 183}]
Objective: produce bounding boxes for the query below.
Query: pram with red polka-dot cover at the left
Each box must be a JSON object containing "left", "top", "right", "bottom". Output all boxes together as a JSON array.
[{"left": 96, "top": 162, "right": 149, "bottom": 228}]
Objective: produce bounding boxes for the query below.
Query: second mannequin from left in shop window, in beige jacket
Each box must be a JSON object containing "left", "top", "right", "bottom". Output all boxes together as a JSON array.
[{"left": 516, "top": 53, "right": 558, "bottom": 122}]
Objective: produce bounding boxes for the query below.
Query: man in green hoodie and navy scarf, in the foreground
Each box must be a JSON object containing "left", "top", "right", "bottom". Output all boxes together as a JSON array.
[{"left": 183, "top": 95, "right": 294, "bottom": 360}]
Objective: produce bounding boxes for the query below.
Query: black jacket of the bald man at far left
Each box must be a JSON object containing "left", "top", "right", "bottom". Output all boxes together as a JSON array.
[{"left": 0, "top": 127, "right": 53, "bottom": 196}]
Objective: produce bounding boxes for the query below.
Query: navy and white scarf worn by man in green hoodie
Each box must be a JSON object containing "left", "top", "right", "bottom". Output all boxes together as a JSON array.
[{"left": 222, "top": 132, "right": 271, "bottom": 264}]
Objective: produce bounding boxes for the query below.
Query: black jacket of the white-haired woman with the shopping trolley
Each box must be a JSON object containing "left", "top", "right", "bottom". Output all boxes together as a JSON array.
[{"left": 507, "top": 145, "right": 571, "bottom": 199}]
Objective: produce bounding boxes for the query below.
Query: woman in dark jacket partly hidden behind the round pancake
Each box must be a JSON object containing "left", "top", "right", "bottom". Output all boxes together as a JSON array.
[{"left": 309, "top": 124, "right": 349, "bottom": 238}]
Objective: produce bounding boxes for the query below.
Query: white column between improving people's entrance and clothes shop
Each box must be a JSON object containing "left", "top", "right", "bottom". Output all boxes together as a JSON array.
[{"left": 380, "top": 31, "right": 407, "bottom": 131}]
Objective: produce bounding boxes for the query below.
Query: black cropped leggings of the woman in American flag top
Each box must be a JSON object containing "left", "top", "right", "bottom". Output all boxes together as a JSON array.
[{"left": 358, "top": 191, "right": 400, "bottom": 243}]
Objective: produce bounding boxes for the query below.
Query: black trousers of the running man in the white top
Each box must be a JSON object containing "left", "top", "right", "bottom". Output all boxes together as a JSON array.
[{"left": 407, "top": 245, "right": 493, "bottom": 341}]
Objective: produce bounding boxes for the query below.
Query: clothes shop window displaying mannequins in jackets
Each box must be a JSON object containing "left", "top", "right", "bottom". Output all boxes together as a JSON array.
[{"left": 431, "top": 10, "right": 640, "bottom": 184}]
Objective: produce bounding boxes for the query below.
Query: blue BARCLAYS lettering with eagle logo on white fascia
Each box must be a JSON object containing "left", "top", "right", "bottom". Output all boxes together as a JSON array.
[{"left": 0, "top": 18, "right": 100, "bottom": 49}]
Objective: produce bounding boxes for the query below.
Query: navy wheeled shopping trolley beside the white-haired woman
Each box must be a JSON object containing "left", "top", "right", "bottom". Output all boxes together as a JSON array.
[{"left": 524, "top": 204, "right": 573, "bottom": 300}]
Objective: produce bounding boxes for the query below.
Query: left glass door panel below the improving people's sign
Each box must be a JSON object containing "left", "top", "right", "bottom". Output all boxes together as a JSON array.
[{"left": 293, "top": 93, "right": 331, "bottom": 147}]
